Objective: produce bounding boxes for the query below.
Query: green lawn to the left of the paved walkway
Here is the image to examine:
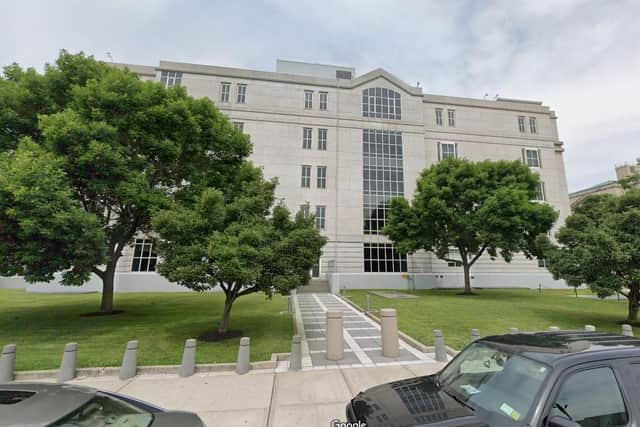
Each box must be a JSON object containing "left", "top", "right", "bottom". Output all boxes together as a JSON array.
[{"left": 0, "top": 289, "right": 293, "bottom": 370}]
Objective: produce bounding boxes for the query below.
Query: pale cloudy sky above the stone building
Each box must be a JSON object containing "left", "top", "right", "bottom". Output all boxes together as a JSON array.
[{"left": 0, "top": 0, "right": 640, "bottom": 191}]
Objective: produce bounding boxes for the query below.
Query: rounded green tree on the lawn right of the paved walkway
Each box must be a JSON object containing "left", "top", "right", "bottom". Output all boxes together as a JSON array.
[{"left": 383, "top": 159, "right": 557, "bottom": 294}]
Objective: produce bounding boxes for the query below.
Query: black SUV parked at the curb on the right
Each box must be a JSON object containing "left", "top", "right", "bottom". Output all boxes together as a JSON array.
[{"left": 347, "top": 331, "right": 640, "bottom": 427}]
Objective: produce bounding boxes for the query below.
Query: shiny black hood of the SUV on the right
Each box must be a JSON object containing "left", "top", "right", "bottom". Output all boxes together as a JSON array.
[{"left": 350, "top": 375, "right": 488, "bottom": 427}]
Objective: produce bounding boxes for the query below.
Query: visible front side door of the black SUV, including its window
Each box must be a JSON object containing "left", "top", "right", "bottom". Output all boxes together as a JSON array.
[{"left": 540, "top": 362, "right": 635, "bottom": 427}]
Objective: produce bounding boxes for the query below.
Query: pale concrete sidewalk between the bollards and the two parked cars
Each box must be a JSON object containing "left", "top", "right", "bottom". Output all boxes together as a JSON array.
[{"left": 65, "top": 362, "right": 443, "bottom": 427}]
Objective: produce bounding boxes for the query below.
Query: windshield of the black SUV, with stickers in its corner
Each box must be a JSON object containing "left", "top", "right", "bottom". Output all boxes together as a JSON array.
[{"left": 438, "top": 343, "right": 551, "bottom": 421}]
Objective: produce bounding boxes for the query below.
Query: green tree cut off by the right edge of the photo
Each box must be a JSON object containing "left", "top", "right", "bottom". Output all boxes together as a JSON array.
[{"left": 540, "top": 189, "right": 640, "bottom": 322}]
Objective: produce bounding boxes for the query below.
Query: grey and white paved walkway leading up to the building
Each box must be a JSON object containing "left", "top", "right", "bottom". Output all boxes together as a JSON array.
[{"left": 295, "top": 293, "right": 435, "bottom": 368}]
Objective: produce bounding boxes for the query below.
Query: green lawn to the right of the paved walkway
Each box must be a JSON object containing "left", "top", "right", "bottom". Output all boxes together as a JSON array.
[{"left": 347, "top": 289, "right": 627, "bottom": 349}]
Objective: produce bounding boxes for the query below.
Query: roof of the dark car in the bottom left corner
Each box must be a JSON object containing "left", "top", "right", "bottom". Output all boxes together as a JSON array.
[{"left": 0, "top": 383, "right": 96, "bottom": 426}]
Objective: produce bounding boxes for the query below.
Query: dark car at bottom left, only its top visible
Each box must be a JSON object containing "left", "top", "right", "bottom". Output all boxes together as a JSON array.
[{"left": 0, "top": 383, "right": 204, "bottom": 427}]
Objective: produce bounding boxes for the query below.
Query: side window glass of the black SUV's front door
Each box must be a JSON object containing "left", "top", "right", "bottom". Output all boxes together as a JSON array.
[{"left": 550, "top": 368, "right": 629, "bottom": 427}]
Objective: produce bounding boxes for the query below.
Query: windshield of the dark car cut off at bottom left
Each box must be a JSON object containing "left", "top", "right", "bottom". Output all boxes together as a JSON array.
[{"left": 50, "top": 394, "right": 153, "bottom": 427}]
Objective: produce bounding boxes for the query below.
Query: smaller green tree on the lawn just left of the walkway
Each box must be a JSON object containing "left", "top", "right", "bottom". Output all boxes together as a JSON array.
[{"left": 153, "top": 163, "right": 326, "bottom": 336}]
